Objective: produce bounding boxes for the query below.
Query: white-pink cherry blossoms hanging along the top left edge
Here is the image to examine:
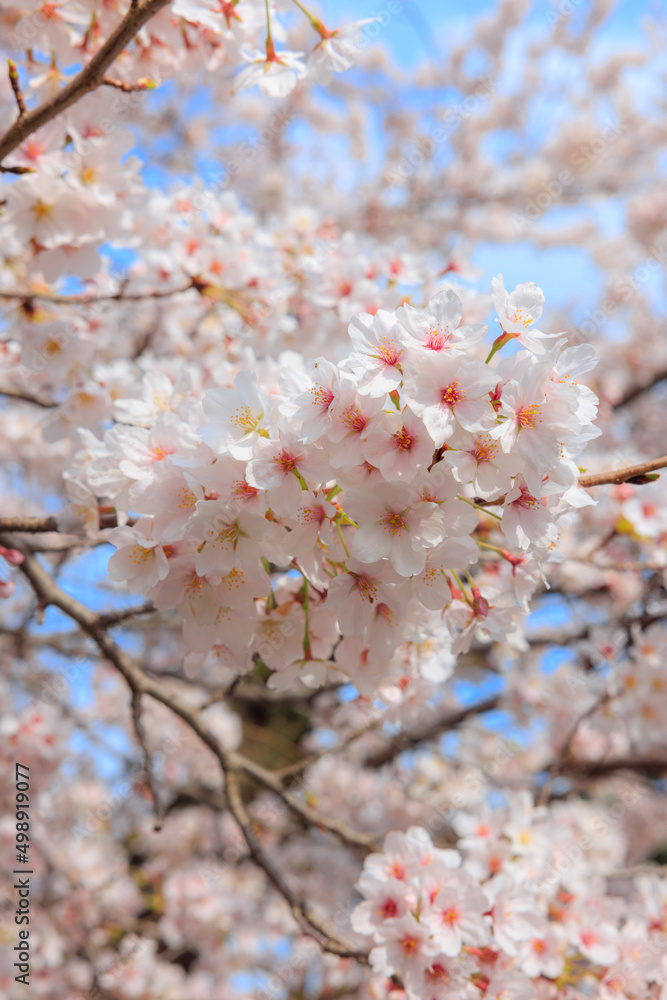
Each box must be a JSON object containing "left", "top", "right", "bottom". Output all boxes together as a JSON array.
[{"left": 3, "top": 0, "right": 377, "bottom": 103}]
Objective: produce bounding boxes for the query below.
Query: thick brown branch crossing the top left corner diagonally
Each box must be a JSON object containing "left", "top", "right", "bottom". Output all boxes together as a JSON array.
[{"left": 0, "top": 0, "right": 169, "bottom": 162}]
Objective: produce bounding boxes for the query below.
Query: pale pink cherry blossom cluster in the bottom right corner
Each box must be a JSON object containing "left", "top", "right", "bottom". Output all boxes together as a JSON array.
[{"left": 352, "top": 793, "right": 667, "bottom": 1000}]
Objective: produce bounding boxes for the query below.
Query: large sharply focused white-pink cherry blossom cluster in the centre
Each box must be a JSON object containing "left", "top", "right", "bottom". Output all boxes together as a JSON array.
[{"left": 60, "top": 279, "right": 596, "bottom": 691}]
